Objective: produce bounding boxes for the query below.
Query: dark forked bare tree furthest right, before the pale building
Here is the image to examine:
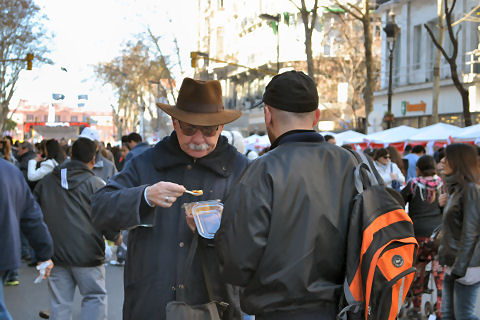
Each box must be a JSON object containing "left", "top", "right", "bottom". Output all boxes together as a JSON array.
[{"left": 424, "top": 0, "right": 472, "bottom": 127}]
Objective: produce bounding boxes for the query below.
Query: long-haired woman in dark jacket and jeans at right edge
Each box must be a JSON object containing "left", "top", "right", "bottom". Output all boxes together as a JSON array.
[{"left": 439, "top": 143, "right": 480, "bottom": 320}]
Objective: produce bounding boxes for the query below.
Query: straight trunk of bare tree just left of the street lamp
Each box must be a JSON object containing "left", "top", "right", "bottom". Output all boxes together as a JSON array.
[{"left": 362, "top": 0, "right": 375, "bottom": 118}]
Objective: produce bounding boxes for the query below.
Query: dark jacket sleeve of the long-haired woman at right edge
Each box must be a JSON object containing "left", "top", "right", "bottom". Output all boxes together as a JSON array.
[{"left": 452, "top": 183, "right": 480, "bottom": 277}]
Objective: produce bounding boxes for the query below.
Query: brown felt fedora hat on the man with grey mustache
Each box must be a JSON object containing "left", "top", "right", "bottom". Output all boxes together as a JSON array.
[{"left": 157, "top": 78, "right": 242, "bottom": 126}]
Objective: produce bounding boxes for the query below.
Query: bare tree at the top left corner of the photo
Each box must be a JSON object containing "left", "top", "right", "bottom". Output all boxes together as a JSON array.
[{"left": 0, "top": 0, "right": 50, "bottom": 133}]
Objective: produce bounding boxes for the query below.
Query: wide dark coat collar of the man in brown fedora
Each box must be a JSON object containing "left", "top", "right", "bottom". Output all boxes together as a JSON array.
[{"left": 153, "top": 131, "right": 237, "bottom": 177}]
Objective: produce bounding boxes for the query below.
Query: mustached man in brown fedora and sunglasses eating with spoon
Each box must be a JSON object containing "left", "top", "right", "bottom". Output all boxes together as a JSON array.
[{"left": 93, "top": 78, "right": 248, "bottom": 320}]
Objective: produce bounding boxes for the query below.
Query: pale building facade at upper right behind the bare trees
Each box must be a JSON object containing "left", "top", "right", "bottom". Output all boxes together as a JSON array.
[{"left": 373, "top": 0, "right": 480, "bottom": 127}]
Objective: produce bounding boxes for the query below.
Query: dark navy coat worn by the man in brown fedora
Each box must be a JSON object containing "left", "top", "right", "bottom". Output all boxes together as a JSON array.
[{"left": 93, "top": 132, "right": 248, "bottom": 320}]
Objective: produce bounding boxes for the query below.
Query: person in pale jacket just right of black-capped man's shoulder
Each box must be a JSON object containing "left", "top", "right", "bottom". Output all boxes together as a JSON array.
[{"left": 373, "top": 148, "right": 405, "bottom": 191}]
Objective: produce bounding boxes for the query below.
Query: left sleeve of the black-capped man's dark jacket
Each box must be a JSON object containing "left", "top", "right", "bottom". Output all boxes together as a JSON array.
[{"left": 215, "top": 160, "right": 272, "bottom": 287}]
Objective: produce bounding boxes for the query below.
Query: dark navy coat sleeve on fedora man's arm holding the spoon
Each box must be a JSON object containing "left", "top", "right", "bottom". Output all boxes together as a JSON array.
[{"left": 92, "top": 158, "right": 155, "bottom": 231}]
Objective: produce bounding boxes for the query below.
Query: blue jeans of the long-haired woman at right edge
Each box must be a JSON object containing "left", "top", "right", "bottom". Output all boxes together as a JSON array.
[{"left": 442, "top": 274, "right": 480, "bottom": 320}]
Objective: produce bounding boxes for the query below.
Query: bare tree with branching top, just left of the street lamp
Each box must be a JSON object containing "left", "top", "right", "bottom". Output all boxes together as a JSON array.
[{"left": 334, "top": 0, "right": 375, "bottom": 117}]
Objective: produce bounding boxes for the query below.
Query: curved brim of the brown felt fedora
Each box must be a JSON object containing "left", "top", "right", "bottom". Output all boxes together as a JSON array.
[{"left": 156, "top": 102, "right": 242, "bottom": 126}]
